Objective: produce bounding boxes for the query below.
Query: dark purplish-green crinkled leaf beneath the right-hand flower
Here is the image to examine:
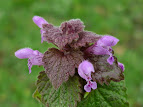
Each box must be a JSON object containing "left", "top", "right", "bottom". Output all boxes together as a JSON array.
[{"left": 89, "top": 55, "right": 124, "bottom": 85}]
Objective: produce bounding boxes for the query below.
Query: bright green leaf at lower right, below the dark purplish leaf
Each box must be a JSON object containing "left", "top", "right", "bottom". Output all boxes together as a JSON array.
[{"left": 77, "top": 81, "right": 129, "bottom": 107}]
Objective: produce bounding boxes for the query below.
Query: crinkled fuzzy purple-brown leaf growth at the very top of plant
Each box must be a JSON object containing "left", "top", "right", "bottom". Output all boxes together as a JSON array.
[{"left": 43, "top": 19, "right": 84, "bottom": 49}]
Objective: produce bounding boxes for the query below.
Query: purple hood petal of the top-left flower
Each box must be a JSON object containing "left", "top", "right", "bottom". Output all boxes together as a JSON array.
[{"left": 33, "top": 16, "right": 48, "bottom": 28}]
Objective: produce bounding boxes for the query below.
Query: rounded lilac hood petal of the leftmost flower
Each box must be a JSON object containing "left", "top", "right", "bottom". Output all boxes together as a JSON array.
[{"left": 15, "top": 48, "right": 33, "bottom": 59}]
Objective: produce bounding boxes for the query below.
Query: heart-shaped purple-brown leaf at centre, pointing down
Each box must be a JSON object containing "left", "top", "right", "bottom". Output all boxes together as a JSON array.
[{"left": 43, "top": 48, "right": 84, "bottom": 88}]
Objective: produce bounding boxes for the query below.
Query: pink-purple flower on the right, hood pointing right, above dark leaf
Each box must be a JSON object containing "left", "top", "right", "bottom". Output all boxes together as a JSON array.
[{"left": 86, "top": 35, "right": 119, "bottom": 65}]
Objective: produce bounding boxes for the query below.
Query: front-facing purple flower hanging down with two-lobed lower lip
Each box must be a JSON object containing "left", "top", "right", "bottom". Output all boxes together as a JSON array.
[{"left": 78, "top": 60, "right": 97, "bottom": 92}]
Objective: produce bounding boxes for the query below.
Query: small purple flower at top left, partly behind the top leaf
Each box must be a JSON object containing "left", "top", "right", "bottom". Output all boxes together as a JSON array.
[{"left": 33, "top": 16, "right": 48, "bottom": 43}]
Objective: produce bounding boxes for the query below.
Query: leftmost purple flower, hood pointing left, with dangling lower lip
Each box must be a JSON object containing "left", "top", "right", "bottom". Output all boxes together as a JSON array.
[{"left": 15, "top": 48, "right": 43, "bottom": 73}]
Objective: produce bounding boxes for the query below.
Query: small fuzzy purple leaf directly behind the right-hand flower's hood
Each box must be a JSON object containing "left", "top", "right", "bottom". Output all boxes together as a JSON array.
[{"left": 71, "top": 31, "right": 101, "bottom": 48}]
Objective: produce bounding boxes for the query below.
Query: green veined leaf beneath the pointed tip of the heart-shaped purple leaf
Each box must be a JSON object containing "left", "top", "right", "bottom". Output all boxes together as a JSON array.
[{"left": 36, "top": 71, "right": 82, "bottom": 107}]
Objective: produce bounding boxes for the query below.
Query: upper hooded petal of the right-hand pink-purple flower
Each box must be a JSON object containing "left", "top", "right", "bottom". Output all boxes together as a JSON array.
[{"left": 97, "top": 35, "right": 119, "bottom": 46}]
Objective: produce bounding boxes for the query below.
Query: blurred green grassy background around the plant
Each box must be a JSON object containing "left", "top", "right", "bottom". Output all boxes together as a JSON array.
[{"left": 0, "top": 0, "right": 143, "bottom": 107}]
